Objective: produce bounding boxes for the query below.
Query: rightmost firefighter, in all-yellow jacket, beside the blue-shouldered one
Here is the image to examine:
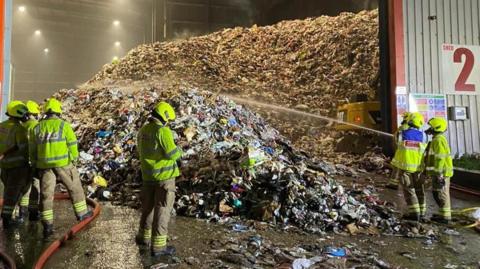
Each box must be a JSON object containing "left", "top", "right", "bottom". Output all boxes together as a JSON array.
[{"left": 425, "top": 118, "right": 453, "bottom": 224}]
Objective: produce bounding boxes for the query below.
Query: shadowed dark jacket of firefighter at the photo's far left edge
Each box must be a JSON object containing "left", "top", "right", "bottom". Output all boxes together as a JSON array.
[{"left": 0, "top": 119, "right": 28, "bottom": 169}]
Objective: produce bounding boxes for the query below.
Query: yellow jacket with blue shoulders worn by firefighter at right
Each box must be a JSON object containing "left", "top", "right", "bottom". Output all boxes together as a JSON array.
[{"left": 392, "top": 129, "right": 427, "bottom": 173}]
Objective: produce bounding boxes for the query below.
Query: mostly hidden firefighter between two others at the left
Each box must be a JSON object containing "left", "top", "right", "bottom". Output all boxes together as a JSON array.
[{"left": 19, "top": 100, "right": 40, "bottom": 221}]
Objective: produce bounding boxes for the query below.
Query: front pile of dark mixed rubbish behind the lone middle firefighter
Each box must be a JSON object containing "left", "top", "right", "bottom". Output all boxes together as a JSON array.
[{"left": 56, "top": 85, "right": 399, "bottom": 232}]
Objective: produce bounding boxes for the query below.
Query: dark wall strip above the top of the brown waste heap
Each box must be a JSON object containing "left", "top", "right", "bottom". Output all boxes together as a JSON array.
[{"left": 153, "top": 0, "right": 378, "bottom": 41}]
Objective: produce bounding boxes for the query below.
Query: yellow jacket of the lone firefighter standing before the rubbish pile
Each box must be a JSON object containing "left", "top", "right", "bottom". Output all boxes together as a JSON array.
[{"left": 138, "top": 120, "right": 182, "bottom": 181}]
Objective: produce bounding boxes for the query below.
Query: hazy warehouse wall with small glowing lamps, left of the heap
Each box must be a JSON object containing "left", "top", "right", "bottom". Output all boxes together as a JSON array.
[{"left": 12, "top": 0, "right": 151, "bottom": 101}]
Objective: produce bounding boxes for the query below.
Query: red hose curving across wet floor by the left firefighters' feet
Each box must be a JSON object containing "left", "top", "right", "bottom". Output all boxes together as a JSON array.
[{"left": 33, "top": 194, "right": 100, "bottom": 269}]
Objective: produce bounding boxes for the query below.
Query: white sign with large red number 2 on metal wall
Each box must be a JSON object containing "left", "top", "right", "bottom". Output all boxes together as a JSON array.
[{"left": 442, "top": 44, "right": 480, "bottom": 95}]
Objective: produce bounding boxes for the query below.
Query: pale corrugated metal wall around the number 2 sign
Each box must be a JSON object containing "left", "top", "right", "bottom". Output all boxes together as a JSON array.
[{"left": 403, "top": 0, "right": 480, "bottom": 154}]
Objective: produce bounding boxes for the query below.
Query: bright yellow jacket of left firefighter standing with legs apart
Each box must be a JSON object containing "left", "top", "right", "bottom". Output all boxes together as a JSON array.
[{"left": 29, "top": 117, "right": 78, "bottom": 169}]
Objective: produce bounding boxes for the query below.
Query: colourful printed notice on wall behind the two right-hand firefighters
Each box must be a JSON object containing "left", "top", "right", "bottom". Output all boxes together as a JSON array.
[{"left": 408, "top": 93, "right": 447, "bottom": 123}]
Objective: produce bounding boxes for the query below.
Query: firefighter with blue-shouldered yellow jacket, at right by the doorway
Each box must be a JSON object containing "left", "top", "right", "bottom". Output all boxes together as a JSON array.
[{"left": 392, "top": 112, "right": 427, "bottom": 221}]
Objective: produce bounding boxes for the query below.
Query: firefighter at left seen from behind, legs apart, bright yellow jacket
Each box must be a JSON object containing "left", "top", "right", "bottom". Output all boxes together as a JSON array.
[{"left": 29, "top": 98, "right": 93, "bottom": 237}]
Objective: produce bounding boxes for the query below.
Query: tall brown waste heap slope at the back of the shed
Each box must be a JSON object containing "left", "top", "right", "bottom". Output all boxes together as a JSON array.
[{"left": 89, "top": 10, "right": 379, "bottom": 115}]
